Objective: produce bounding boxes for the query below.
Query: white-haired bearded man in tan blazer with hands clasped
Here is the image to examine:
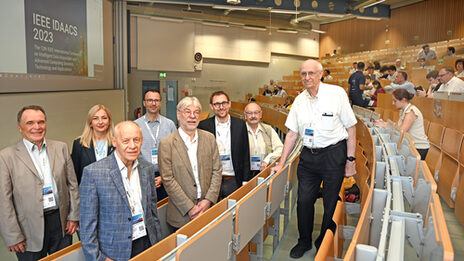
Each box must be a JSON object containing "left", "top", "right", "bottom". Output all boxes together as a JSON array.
[{"left": 158, "top": 97, "right": 222, "bottom": 231}]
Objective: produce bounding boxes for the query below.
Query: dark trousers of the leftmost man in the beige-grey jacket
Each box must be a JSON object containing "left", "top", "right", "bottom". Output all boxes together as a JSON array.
[{"left": 16, "top": 210, "right": 72, "bottom": 261}]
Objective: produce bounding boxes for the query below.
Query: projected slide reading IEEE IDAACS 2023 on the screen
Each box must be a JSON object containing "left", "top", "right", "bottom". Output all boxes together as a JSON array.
[{"left": 0, "top": 0, "right": 104, "bottom": 78}]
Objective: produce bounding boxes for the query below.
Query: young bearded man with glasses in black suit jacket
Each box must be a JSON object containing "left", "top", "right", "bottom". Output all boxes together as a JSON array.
[{"left": 198, "top": 91, "right": 252, "bottom": 199}]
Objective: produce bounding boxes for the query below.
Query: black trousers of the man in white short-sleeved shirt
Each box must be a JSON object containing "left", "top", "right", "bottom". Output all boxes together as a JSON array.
[{"left": 297, "top": 141, "right": 346, "bottom": 249}]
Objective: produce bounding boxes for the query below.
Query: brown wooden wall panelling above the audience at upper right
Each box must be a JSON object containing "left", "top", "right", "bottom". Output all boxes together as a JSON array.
[{"left": 319, "top": 0, "right": 464, "bottom": 56}]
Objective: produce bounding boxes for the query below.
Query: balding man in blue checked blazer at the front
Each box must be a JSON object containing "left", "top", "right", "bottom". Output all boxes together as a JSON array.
[{"left": 80, "top": 121, "right": 161, "bottom": 260}]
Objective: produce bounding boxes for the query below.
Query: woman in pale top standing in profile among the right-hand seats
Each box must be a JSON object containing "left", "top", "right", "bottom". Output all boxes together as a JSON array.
[{"left": 375, "top": 89, "right": 430, "bottom": 160}]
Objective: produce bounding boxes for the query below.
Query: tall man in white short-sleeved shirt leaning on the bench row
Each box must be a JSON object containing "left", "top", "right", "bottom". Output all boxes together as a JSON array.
[{"left": 271, "top": 59, "right": 356, "bottom": 258}]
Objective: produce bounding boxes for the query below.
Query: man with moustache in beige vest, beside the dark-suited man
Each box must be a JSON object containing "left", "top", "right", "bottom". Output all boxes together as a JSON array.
[{"left": 243, "top": 102, "right": 282, "bottom": 176}]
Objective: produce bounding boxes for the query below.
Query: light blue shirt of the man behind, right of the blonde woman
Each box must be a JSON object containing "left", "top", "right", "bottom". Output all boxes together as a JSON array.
[{"left": 134, "top": 114, "right": 176, "bottom": 171}]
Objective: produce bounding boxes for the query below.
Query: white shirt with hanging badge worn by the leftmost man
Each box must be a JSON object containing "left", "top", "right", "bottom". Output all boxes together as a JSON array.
[{"left": 23, "top": 138, "right": 60, "bottom": 210}]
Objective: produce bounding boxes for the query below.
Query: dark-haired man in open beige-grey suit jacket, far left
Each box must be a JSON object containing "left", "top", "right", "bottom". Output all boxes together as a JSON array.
[{"left": 0, "top": 105, "right": 79, "bottom": 260}]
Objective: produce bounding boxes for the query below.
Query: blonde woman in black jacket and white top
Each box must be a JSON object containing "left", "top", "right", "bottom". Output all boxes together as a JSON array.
[{"left": 71, "top": 104, "right": 114, "bottom": 184}]
